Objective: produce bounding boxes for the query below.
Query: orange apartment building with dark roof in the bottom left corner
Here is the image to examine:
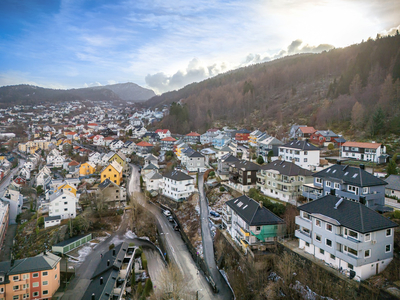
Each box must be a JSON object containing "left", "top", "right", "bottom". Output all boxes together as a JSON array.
[{"left": 0, "top": 253, "right": 61, "bottom": 300}]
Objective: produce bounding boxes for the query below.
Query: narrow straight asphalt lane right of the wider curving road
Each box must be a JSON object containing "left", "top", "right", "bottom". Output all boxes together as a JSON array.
[{"left": 198, "top": 173, "right": 233, "bottom": 300}]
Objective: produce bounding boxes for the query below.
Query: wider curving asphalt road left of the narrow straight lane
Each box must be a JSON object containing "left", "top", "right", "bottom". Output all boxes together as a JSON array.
[{"left": 128, "top": 165, "right": 217, "bottom": 299}]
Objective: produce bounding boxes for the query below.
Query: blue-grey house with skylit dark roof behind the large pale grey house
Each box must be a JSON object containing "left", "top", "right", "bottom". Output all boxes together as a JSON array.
[{"left": 303, "top": 164, "right": 391, "bottom": 211}]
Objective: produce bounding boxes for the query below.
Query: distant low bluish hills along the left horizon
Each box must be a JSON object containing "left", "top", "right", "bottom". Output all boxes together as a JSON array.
[{"left": 0, "top": 83, "right": 155, "bottom": 107}]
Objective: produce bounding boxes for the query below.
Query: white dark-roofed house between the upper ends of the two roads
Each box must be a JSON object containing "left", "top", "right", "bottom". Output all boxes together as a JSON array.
[{"left": 160, "top": 170, "right": 195, "bottom": 202}]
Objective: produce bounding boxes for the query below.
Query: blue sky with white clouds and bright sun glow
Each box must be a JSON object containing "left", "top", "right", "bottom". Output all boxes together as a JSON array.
[{"left": 0, "top": 0, "right": 400, "bottom": 94}]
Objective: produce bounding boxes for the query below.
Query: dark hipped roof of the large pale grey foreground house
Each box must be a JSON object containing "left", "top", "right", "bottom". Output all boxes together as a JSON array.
[{"left": 298, "top": 195, "right": 398, "bottom": 233}]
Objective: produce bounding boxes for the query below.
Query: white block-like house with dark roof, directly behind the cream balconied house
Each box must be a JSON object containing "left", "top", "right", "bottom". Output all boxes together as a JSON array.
[{"left": 279, "top": 140, "right": 321, "bottom": 171}]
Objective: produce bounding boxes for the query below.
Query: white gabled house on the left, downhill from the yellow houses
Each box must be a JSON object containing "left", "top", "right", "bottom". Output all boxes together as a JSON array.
[{"left": 49, "top": 190, "right": 77, "bottom": 219}]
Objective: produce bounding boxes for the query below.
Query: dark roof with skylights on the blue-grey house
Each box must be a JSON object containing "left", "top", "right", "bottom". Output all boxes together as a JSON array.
[{"left": 313, "top": 165, "right": 387, "bottom": 187}]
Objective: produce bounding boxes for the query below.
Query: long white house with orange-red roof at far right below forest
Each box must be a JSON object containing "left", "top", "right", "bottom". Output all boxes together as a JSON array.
[{"left": 340, "top": 142, "right": 388, "bottom": 163}]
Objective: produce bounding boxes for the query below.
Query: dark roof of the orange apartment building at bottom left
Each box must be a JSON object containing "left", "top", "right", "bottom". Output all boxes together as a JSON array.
[{"left": 0, "top": 253, "right": 61, "bottom": 275}]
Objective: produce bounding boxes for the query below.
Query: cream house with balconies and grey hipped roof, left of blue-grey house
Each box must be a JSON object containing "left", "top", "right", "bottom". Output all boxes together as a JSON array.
[{"left": 257, "top": 160, "right": 314, "bottom": 203}]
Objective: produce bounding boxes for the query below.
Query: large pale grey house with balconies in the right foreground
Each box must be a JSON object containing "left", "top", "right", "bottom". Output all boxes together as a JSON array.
[{"left": 295, "top": 195, "right": 398, "bottom": 280}]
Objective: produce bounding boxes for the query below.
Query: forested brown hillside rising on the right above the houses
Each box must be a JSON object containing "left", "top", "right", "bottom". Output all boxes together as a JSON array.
[{"left": 146, "top": 35, "right": 400, "bottom": 135}]
